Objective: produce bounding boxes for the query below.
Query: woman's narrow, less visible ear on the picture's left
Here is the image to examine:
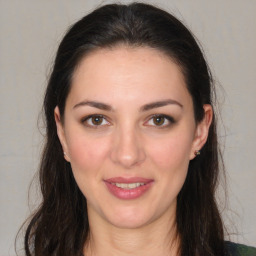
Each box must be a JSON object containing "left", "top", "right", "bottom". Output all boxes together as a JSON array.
[{"left": 54, "top": 106, "right": 70, "bottom": 162}]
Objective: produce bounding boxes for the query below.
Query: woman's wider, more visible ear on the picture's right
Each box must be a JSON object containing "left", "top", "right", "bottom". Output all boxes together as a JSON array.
[{"left": 190, "top": 104, "right": 213, "bottom": 160}]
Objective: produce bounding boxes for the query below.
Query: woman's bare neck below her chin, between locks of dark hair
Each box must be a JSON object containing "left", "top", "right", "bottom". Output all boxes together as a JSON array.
[{"left": 84, "top": 206, "right": 179, "bottom": 256}]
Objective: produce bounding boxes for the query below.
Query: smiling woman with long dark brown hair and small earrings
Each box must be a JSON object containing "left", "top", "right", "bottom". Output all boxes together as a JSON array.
[{"left": 25, "top": 4, "right": 255, "bottom": 256}]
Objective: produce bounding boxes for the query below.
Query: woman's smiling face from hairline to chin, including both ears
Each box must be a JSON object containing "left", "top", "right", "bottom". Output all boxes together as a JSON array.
[{"left": 55, "top": 46, "right": 211, "bottom": 228}]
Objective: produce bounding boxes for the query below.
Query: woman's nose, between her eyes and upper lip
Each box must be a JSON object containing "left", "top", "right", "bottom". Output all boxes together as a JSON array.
[{"left": 110, "top": 125, "right": 146, "bottom": 169}]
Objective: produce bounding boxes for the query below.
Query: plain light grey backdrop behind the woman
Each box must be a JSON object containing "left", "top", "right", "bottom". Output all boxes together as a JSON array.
[{"left": 0, "top": 0, "right": 256, "bottom": 255}]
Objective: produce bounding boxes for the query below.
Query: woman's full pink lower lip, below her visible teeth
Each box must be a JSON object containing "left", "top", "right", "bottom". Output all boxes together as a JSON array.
[{"left": 105, "top": 181, "right": 153, "bottom": 200}]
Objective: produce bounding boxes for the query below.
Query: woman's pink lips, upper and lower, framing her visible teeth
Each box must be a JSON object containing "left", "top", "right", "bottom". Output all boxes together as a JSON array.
[{"left": 104, "top": 177, "right": 153, "bottom": 200}]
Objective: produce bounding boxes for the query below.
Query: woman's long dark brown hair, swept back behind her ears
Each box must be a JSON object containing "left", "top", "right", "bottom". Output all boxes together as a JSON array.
[{"left": 22, "top": 3, "right": 224, "bottom": 256}]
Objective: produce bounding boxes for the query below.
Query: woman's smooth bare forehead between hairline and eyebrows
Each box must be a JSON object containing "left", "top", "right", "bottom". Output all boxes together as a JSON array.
[{"left": 69, "top": 46, "right": 189, "bottom": 108}]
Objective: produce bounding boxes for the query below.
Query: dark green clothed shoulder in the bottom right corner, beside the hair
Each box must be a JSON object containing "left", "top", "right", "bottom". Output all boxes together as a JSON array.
[{"left": 225, "top": 241, "right": 256, "bottom": 256}]
